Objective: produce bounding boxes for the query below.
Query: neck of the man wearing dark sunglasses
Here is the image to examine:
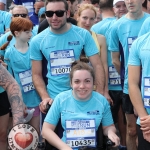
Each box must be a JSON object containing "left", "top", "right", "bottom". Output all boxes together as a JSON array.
[{"left": 50, "top": 23, "right": 71, "bottom": 34}]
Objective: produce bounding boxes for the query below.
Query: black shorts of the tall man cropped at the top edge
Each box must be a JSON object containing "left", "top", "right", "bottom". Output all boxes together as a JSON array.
[{"left": 122, "top": 93, "right": 134, "bottom": 114}]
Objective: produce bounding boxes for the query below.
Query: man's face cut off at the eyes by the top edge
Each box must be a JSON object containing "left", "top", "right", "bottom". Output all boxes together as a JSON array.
[{"left": 125, "top": 0, "right": 144, "bottom": 14}]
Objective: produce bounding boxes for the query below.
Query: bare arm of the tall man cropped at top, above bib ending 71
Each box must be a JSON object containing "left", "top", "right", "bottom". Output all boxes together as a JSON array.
[{"left": 111, "top": 52, "right": 121, "bottom": 74}]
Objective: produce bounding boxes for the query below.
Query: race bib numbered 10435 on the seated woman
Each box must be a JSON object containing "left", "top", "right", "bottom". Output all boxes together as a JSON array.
[{"left": 66, "top": 119, "right": 96, "bottom": 148}]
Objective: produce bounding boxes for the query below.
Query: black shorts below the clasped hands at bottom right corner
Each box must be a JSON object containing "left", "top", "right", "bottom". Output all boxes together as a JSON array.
[{"left": 137, "top": 125, "right": 150, "bottom": 150}]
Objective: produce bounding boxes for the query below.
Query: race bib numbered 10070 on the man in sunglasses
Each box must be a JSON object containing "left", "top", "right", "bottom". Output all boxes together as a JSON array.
[{"left": 50, "top": 50, "right": 75, "bottom": 76}]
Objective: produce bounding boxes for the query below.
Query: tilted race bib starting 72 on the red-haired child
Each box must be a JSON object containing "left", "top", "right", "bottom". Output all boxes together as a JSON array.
[{"left": 19, "top": 69, "right": 35, "bottom": 92}]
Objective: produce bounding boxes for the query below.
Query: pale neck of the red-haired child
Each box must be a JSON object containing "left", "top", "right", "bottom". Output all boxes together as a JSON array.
[{"left": 15, "top": 39, "right": 29, "bottom": 53}]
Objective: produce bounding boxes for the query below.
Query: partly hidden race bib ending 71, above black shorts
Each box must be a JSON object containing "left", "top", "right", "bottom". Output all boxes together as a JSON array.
[{"left": 108, "top": 66, "right": 121, "bottom": 85}]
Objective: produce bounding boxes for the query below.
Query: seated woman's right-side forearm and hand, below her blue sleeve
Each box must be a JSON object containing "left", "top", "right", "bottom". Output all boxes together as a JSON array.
[{"left": 103, "top": 125, "right": 120, "bottom": 146}]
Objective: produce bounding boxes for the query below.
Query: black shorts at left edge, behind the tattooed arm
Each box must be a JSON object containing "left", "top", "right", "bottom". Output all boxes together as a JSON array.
[{"left": 0, "top": 91, "right": 11, "bottom": 116}]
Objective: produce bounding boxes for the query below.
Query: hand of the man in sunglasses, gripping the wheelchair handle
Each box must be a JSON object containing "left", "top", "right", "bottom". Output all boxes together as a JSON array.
[{"left": 39, "top": 98, "right": 53, "bottom": 114}]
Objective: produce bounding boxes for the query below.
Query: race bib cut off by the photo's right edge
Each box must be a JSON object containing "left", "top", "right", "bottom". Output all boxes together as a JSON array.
[{"left": 144, "top": 77, "right": 150, "bottom": 108}]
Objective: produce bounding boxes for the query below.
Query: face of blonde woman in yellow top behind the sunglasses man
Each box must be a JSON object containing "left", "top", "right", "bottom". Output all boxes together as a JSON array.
[{"left": 77, "top": 9, "right": 96, "bottom": 31}]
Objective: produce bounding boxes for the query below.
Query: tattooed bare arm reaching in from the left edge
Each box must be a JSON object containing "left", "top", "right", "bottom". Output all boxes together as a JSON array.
[{"left": 0, "top": 64, "right": 24, "bottom": 125}]
